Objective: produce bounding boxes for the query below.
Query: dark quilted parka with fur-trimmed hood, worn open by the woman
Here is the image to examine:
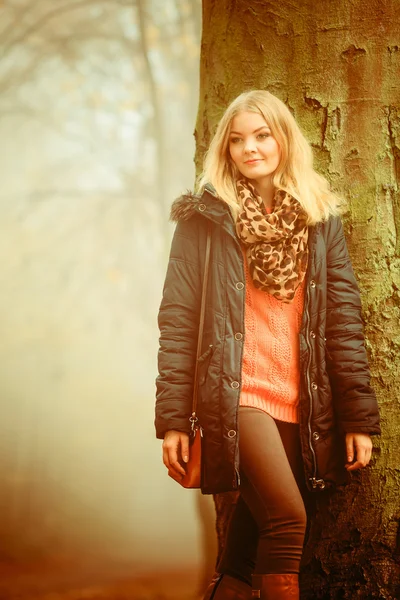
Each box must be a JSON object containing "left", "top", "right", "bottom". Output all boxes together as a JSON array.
[{"left": 155, "top": 186, "right": 380, "bottom": 494}]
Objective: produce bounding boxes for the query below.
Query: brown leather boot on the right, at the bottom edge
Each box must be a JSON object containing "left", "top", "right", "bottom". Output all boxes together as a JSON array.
[{"left": 251, "top": 573, "right": 300, "bottom": 600}]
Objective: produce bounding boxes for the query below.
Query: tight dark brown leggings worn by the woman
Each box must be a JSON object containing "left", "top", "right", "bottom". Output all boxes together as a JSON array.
[{"left": 218, "top": 407, "right": 307, "bottom": 582}]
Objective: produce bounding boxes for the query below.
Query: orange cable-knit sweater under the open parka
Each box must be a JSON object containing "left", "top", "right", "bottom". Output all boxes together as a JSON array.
[{"left": 240, "top": 248, "right": 304, "bottom": 423}]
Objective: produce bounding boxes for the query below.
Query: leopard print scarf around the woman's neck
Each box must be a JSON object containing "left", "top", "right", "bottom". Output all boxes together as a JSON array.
[{"left": 236, "top": 179, "right": 308, "bottom": 302}]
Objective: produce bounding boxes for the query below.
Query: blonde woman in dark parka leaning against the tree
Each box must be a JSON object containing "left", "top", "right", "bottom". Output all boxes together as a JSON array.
[{"left": 156, "top": 91, "right": 380, "bottom": 600}]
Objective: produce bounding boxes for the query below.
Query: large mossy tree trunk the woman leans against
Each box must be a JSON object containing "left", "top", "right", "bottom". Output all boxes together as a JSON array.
[{"left": 196, "top": 0, "right": 400, "bottom": 599}]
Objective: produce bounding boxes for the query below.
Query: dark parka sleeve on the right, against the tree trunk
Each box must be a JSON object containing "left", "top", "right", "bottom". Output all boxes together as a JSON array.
[{"left": 326, "top": 218, "right": 380, "bottom": 435}]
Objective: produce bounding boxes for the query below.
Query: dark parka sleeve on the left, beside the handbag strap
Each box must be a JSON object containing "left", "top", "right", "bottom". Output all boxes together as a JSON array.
[{"left": 155, "top": 218, "right": 201, "bottom": 438}]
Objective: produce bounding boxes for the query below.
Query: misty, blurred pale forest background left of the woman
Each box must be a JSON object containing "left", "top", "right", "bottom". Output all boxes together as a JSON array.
[{"left": 0, "top": 0, "right": 206, "bottom": 599}]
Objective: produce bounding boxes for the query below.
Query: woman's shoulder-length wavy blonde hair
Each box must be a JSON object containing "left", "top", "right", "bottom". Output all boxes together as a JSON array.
[{"left": 198, "top": 90, "right": 343, "bottom": 225}]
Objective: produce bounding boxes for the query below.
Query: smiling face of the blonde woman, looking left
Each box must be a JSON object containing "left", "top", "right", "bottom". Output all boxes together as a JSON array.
[{"left": 229, "top": 111, "right": 281, "bottom": 184}]
